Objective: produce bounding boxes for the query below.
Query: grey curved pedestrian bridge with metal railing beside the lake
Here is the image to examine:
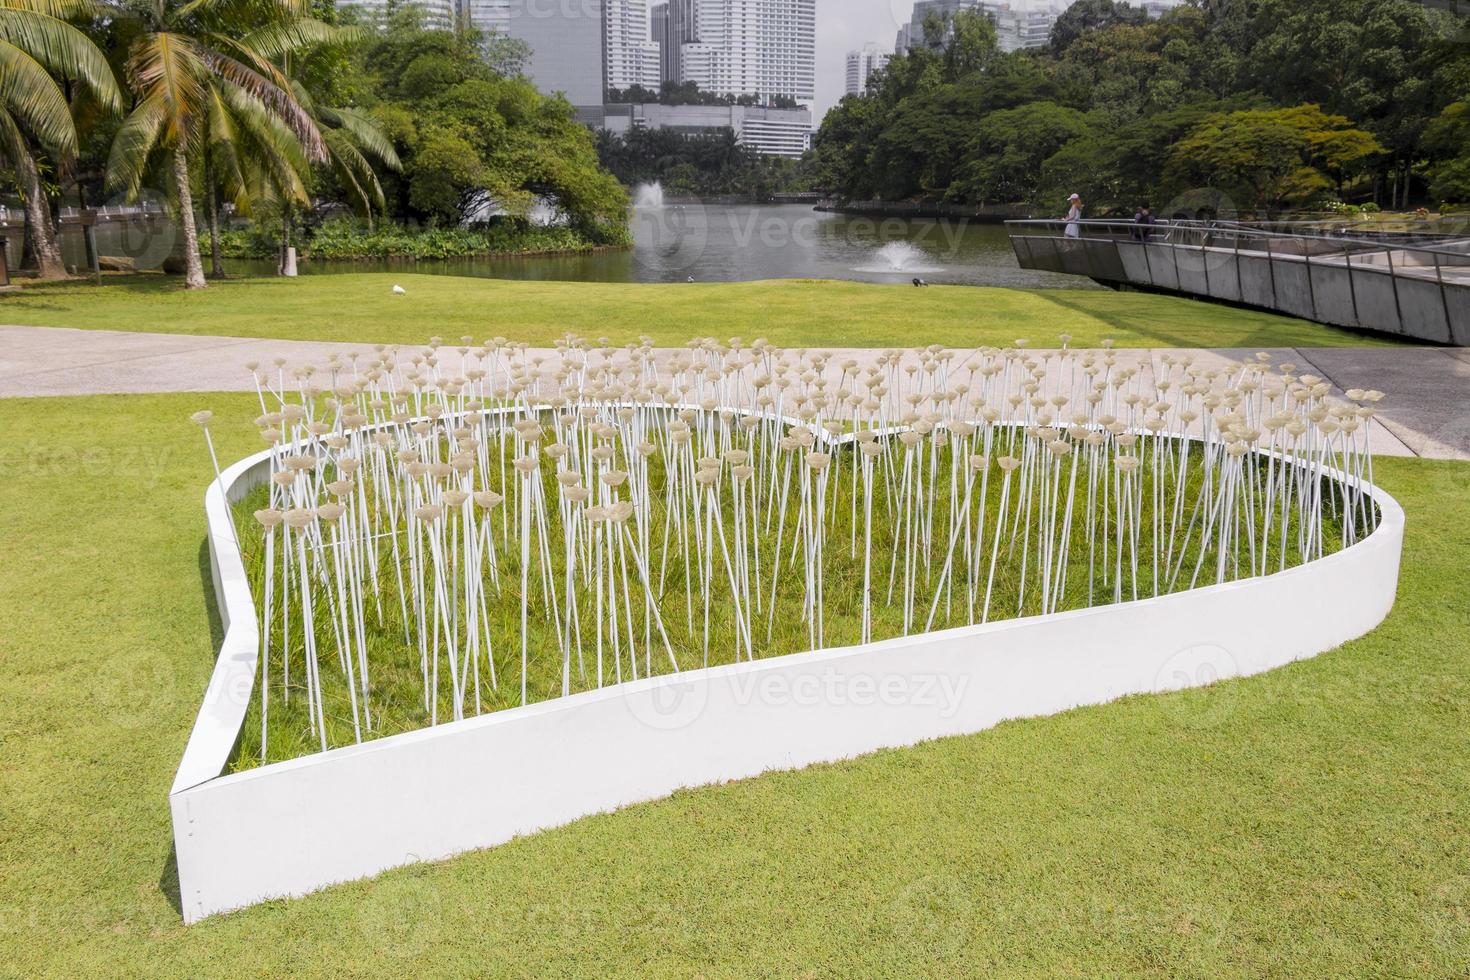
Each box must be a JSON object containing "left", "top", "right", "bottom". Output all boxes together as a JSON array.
[{"left": 1005, "top": 220, "right": 1470, "bottom": 347}]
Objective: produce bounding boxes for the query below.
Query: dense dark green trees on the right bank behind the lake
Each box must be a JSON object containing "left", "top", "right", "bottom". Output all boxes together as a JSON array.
[{"left": 810, "top": 0, "right": 1470, "bottom": 213}]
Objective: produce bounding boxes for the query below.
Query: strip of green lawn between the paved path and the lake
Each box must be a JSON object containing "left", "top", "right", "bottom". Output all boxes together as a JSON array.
[{"left": 0, "top": 275, "right": 1394, "bottom": 348}]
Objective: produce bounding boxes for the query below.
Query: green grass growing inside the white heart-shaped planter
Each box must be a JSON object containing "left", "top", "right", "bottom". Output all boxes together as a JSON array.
[{"left": 231, "top": 439, "right": 1361, "bottom": 771}]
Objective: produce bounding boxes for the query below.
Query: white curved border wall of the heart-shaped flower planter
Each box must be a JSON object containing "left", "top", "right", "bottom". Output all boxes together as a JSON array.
[{"left": 169, "top": 417, "right": 1404, "bottom": 923}]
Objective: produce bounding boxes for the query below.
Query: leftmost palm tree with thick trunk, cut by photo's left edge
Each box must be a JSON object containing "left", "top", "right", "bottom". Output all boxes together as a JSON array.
[{"left": 0, "top": 0, "right": 122, "bottom": 279}]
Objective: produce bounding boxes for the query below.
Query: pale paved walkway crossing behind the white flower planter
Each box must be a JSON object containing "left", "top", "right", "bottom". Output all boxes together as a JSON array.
[{"left": 0, "top": 326, "right": 1470, "bottom": 460}]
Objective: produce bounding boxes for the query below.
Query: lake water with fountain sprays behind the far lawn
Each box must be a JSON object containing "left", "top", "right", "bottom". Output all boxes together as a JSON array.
[{"left": 45, "top": 204, "right": 1097, "bottom": 288}]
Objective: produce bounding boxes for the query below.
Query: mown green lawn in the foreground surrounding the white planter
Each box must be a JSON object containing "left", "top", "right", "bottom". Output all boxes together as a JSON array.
[{"left": 0, "top": 387, "right": 1470, "bottom": 977}]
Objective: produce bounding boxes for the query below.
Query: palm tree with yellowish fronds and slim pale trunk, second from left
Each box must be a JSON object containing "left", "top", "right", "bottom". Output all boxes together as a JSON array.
[{"left": 107, "top": 0, "right": 332, "bottom": 289}]
